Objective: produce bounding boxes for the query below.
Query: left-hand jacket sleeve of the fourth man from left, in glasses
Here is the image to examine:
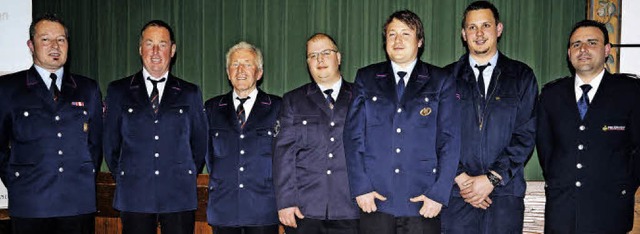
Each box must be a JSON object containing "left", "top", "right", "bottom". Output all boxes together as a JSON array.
[{"left": 273, "top": 95, "right": 300, "bottom": 210}]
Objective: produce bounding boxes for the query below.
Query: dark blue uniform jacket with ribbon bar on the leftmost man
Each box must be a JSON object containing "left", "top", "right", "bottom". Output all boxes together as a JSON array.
[{"left": 0, "top": 66, "right": 102, "bottom": 218}]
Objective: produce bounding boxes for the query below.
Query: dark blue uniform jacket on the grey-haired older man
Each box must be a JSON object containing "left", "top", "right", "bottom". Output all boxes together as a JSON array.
[{"left": 205, "top": 90, "right": 282, "bottom": 226}]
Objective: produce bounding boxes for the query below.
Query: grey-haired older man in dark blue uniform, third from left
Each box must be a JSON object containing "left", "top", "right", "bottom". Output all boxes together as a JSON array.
[{"left": 205, "top": 42, "right": 282, "bottom": 234}]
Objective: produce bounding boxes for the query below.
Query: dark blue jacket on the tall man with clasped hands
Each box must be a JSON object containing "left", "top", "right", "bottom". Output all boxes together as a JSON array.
[{"left": 446, "top": 53, "right": 538, "bottom": 197}]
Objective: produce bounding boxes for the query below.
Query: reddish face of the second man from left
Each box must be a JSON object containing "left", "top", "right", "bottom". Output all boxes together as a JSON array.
[{"left": 139, "top": 26, "right": 176, "bottom": 77}]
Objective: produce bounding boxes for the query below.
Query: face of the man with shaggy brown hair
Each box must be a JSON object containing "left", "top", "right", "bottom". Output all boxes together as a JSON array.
[{"left": 385, "top": 19, "right": 422, "bottom": 67}]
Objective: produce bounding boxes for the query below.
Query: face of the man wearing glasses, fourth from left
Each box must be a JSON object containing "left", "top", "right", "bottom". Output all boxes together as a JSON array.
[{"left": 307, "top": 38, "right": 341, "bottom": 84}]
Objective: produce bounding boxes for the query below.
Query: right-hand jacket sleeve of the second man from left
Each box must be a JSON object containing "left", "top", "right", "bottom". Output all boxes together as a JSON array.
[{"left": 190, "top": 88, "right": 209, "bottom": 173}]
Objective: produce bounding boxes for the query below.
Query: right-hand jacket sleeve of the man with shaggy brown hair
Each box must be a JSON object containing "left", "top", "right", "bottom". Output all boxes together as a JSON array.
[{"left": 424, "top": 70, "right": 460, "bottom": 206}]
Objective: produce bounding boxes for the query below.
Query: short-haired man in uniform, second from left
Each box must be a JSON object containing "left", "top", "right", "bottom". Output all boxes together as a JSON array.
[{"left": 104, "top": 20, "right": 207, "bottom": 234}]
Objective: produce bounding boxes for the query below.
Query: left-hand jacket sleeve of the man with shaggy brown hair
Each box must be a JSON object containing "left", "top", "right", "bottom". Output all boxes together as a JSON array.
[{"left": 343, "top": 70, "right": 374, "bottom": 198}]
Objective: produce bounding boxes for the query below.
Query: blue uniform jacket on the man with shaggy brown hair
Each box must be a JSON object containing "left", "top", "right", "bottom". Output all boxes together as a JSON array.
[{"left": 344, "top": 61, "right": 460, "bottom": 216}]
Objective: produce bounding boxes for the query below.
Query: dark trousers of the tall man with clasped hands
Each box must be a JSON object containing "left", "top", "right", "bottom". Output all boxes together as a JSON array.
[{"left": 441, "top": 196, "right": 524, "bottom": 234}]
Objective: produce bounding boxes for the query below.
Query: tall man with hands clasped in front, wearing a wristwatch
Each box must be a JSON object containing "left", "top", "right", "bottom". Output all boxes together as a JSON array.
[{"left": 442, "top": 1, "right": 538, "bottom": 233}]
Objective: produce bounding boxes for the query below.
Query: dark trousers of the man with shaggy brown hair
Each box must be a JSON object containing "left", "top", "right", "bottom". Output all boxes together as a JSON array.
[{"left": 359, "top": 212, "right": 440, "bottom": 234}]
